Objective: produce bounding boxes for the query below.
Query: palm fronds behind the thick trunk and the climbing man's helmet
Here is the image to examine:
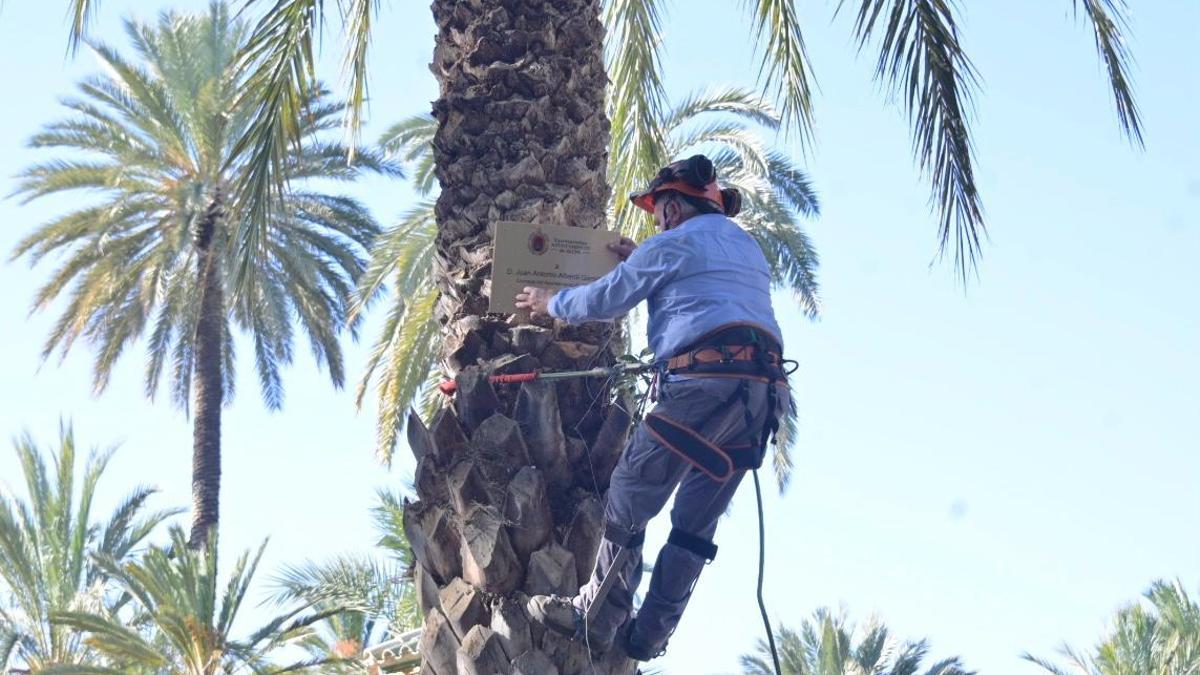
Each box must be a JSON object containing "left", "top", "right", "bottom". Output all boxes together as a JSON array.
[{"left": 352, "top": 89, "right": 821, "bottom": 486}]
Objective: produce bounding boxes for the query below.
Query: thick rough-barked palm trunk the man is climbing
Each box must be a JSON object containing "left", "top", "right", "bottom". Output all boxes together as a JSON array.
[{"left": 404, "top": 0, "right": 634, "bottom": 675}]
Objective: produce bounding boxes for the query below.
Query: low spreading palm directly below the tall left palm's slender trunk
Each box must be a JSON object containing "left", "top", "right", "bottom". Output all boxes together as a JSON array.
[{"left": 42, "top": 527, "right": 337, "bottom": 675}]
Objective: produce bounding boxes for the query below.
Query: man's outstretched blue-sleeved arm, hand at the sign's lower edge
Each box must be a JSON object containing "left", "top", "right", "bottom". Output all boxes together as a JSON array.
[{"left": 517, "top": 235, "right": 679, "bottom": 323}]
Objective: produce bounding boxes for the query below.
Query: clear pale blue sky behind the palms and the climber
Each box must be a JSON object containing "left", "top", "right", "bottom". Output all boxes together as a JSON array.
[{"left": 0, "top": 0, "right": 1200, "bottom": 674}]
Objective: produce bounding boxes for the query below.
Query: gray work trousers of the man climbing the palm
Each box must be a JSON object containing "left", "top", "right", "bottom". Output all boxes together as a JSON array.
[{"left": 574, "top": 377, "right": 788, "bottom": 651}]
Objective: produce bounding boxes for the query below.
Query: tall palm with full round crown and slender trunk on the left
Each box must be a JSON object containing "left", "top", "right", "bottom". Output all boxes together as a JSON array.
[{"left": 13, "top": 2, "right": 398, "bottom": 544}]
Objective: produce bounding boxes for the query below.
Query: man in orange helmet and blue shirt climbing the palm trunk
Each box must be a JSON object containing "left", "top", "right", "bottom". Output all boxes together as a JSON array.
[{"left": 517, "top": 155, "right": 788, "bottom": 661}]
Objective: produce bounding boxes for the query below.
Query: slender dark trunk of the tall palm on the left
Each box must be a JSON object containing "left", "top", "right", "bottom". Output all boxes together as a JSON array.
[{"left": 188, "top": 195, "right": 224, "bottom": 548}]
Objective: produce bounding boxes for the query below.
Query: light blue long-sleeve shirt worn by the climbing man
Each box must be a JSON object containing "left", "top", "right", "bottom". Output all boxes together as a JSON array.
[{"left": 548, "top": 214, "right": 782, "bottom": 358}]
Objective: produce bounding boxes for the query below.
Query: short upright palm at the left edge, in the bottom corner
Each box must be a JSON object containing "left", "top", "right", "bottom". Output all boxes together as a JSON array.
[{"left": 0, "top": 425, "right": 178, "bottom": 673}]
